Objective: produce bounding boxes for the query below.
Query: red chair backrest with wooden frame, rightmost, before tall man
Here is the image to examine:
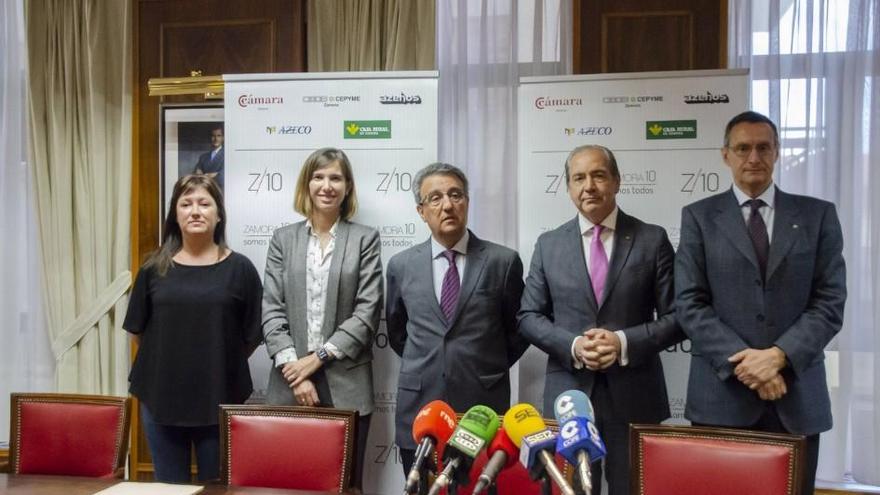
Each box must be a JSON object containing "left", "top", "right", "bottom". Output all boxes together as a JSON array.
[{"left": 630, "top": 425, "right": 805, "bottom": 495}]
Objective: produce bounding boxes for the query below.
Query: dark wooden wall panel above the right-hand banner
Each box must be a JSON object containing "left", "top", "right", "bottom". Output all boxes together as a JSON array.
[{"left": 573, "top": 0, "right": 727, "bottom": 74}]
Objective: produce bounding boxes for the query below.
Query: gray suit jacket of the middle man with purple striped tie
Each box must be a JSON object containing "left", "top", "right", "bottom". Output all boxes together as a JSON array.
[{"left": 385, "top": 233, "right": 528, "bottom": 449}]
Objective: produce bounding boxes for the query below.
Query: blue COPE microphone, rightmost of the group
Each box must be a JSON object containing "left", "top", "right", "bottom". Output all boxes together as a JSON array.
[{"left": 553, "top": 390, "right": 606, "bottom": 493}]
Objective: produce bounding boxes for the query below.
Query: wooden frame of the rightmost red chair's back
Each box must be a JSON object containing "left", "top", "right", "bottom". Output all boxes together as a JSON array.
[{"left": 629, "top": 424, "right": 806, "bottom": 495}]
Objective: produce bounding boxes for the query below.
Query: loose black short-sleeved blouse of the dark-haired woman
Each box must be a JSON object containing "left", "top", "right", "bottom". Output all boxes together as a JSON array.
[{"left": 122, "top": 253, "right": 263, "bottom": 426}]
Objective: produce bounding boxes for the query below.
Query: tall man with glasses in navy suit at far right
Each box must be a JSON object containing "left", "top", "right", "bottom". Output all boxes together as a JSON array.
[{"left": 675, "top": 112, "right": 846, "bottom": 494}]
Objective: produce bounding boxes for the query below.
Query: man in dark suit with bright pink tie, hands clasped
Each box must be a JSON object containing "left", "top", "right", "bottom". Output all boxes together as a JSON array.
[{"left": 519, "top": 145, "right": 684, "bottom": 495}]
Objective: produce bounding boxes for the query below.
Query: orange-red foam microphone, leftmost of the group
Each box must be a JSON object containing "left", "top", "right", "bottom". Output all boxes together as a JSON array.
[{"left": 403, "top": 400, "right": 455, "bottom": 494}]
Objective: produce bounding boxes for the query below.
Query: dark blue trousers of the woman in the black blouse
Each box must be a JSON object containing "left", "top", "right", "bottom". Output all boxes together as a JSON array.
[{"left": 140, "top": 403, "right": 220, "bottom": 483}]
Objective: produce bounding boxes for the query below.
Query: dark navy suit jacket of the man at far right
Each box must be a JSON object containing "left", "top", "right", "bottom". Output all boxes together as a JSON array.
[{"left": 675, "top": 186, "right": 846, "bottom": 435}]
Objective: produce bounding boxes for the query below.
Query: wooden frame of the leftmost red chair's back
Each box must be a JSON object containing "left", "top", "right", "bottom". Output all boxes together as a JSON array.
[{"left": 9, "top": 393, "right": 131, "bottom": 479}]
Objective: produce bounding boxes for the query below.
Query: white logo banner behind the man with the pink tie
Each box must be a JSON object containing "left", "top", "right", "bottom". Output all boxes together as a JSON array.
[{"left": 519, "top": 70, "right": 749, "bottom": 423}]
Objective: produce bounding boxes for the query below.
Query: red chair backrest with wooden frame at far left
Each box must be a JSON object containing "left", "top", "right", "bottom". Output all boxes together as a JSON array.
[{"left": 9, "top": 393, "right": 131, "bottom": 477}]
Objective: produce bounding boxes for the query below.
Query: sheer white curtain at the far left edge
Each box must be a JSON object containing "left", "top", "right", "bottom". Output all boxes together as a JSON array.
[{"left": 0, "top": 0, "right": 55, "bottom": 448}]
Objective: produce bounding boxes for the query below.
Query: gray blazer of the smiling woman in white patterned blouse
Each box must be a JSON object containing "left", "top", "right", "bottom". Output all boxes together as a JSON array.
[{"left": 263, "top": 220, "right": 382, "bottom": 415}]
